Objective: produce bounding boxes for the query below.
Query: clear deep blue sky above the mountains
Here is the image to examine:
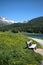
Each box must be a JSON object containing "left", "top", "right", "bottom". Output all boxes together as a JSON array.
[{"left": 0, "top": 0, "right": 43, "bottom": 22}]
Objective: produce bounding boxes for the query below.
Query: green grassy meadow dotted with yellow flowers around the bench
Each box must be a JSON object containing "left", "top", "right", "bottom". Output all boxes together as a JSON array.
[{"left": 0, "top": 32, "right": 42, "bottom": 65}]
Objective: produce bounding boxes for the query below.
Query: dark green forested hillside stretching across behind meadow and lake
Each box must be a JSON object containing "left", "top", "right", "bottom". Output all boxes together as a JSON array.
[{"left": 0, "top": 16, "right": 43, "bottom": 33}]
